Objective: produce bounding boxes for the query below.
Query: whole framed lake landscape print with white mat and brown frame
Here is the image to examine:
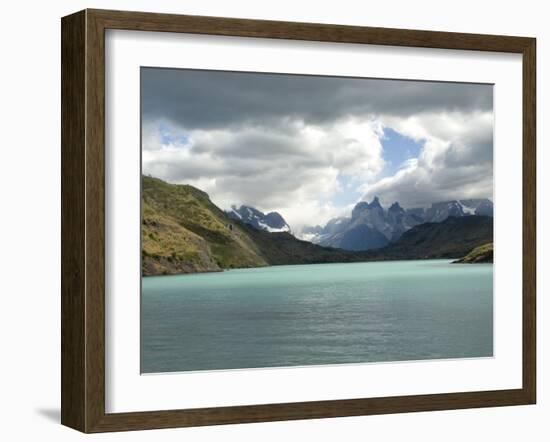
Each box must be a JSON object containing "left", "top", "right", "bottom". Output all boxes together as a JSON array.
[{"left": 61, "top": 10, "right": 536, "bottom": 432}]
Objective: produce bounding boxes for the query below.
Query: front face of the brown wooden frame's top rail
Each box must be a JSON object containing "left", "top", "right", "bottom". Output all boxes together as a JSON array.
[{"left": 88, "top": 10, "right": 530, "bottom": 53}]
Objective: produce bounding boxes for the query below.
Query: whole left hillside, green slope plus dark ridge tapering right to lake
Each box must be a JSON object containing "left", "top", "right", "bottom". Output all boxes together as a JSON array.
[{"left": 141, "top": 176, "right": 382, "bottom": 275}]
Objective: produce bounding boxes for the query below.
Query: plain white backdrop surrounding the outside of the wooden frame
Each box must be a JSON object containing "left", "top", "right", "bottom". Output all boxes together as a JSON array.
[{"left": 0, "top": 0, "right": 550, "bottom": 441}]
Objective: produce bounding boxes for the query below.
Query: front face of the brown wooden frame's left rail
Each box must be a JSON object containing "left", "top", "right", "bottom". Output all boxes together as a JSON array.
[{"left": 85, "top": 11, "right": 105, "bottom": 432}]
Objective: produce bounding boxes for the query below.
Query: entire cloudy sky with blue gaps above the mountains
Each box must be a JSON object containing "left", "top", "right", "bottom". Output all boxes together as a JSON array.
[{"left": 141, "top": 68, "right": 493, "bottom": 232}]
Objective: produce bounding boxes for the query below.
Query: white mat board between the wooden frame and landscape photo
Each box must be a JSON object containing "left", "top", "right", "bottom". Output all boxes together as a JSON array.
[{"left": 105, "top": 31, "right": 522, "bottom": 412}]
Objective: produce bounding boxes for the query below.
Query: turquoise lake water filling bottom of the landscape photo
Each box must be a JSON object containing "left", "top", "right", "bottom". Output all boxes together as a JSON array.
[{"left": 141, "top": 260, "right": 493, "bottom": 373}]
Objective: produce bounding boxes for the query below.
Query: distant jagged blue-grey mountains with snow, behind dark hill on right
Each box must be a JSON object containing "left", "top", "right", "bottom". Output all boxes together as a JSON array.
[{"left": 302, "top": 197, "right": 493, "bottom": 250}]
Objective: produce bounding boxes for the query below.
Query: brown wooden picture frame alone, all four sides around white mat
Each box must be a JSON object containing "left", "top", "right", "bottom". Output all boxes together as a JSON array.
[{"left": 61, "top": 10, "right": 536, "bottom": 432}]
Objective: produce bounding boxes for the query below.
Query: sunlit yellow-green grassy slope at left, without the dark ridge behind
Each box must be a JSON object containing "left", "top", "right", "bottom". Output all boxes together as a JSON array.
[{"left": 142, "top": 176, "right": 267, "bottom": 275}]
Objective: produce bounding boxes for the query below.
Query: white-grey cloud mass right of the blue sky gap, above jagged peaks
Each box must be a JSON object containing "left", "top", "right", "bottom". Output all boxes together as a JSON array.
[{"left": 362, "top": 112, "right": 493, "bottom": 207}]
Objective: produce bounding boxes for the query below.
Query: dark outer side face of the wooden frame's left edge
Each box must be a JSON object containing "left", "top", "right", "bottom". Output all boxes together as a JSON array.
[{"left": 61, "top": 12, "right": 86, "bottom": 429}]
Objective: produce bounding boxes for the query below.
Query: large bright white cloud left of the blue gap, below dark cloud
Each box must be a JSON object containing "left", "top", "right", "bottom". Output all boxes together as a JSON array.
[{"left": 146, "top": 117, "right": 384, "bottom": 230}]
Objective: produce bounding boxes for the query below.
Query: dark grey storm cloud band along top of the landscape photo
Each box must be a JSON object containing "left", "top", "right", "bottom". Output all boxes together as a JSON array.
[{"left": 141, "top": 68, "right": 493, "bottom": 130}]
